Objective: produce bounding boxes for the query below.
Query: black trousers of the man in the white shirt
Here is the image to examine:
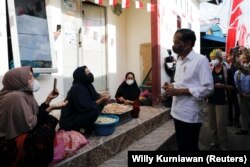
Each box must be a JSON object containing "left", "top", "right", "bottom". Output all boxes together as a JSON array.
[{"left": 174, "top": 119, "right": 202, "bottom": 151}]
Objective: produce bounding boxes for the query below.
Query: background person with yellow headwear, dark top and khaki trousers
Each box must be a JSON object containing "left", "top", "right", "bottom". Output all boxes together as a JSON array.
[{"left": 207, "top": 49, "right": 234, "bottom": 150}]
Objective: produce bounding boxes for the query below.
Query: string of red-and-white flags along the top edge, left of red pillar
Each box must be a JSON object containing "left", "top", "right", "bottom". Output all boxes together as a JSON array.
[{"left": 82, "top": 0, "right": 156, "bottom": 12}]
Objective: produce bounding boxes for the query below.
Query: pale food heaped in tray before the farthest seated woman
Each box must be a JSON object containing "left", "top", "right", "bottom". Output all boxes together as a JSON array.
[{"left": 102, "top": 103, "right": 133, "bottom": 114}]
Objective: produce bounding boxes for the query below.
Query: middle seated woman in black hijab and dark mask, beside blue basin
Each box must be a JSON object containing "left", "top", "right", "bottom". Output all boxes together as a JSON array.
[{"left": 59, "top": 66, "right": 109, "bottom": 135}]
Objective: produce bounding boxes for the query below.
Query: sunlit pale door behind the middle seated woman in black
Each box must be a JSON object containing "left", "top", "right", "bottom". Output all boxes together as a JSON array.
[{"left": 79, "top": 2, "right": 107, "bottom": 91}]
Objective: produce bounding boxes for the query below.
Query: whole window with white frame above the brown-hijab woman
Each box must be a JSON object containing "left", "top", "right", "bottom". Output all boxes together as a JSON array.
[{"left": 7, "top": 0, "right": 56, "bottom": 72}]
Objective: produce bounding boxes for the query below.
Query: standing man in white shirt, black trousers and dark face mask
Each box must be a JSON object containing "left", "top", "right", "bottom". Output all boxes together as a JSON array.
[{"left": 163, "top": 29, "right": 214, "bottom": 151}]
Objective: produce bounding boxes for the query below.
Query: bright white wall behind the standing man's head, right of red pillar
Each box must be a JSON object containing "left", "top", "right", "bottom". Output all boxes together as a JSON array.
[{"left": 159, "top": 0, "right": 200, "bottom": 92}]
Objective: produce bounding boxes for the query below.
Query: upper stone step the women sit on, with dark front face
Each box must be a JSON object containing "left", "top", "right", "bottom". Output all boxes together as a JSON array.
[{"left": 55, "top": 106, "right": 170, "bottom": 167}]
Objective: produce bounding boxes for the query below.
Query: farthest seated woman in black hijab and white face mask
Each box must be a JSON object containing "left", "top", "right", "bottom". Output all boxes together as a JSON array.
[{"left": 115, "top": 72, "right": 140, "bottom": 118}]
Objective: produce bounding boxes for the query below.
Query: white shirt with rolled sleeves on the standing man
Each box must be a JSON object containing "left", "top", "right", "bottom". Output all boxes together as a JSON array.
[{"left": 171, "top": 50, "right": 214, "bottom": 123}]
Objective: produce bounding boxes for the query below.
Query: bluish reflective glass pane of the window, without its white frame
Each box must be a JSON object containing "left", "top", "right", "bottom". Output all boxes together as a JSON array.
[{"left": 14, "top": 0, "right": 52, "bottom": 68}]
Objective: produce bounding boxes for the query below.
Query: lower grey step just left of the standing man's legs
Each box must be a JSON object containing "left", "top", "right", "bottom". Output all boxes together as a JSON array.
[{"left": 98, "top": 120, "right": 176, "bottom": 167}]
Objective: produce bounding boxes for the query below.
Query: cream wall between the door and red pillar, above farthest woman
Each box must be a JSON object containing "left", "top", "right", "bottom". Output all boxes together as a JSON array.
[{"left": 126, "top": 0, "right": 151, "bottom": 84}]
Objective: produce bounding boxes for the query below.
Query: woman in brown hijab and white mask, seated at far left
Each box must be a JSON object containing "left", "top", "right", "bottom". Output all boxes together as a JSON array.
[{"left": 0, "top": 66, "right": 67, "bottom": 167}]
